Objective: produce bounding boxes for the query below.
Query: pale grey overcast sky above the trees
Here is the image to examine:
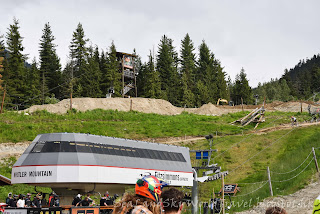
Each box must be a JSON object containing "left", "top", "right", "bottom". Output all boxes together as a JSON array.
[{"left": 0, "top": 0, "right": 320, "bottom": 87}]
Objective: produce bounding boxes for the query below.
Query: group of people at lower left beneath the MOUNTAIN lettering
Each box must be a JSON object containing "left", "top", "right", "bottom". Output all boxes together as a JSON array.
[{"left": 6, "top": 192, "right": 60, "bottom": 208}]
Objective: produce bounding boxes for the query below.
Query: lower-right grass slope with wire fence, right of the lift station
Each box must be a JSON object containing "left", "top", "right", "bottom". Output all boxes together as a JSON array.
[{"left": 189, "top": 126, "right": 320, "bottom": 213}]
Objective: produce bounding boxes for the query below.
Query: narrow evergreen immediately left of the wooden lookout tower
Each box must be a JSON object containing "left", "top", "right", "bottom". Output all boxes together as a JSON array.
[{"left": 104, "top": 42, "right": 122, "bottom": 97}]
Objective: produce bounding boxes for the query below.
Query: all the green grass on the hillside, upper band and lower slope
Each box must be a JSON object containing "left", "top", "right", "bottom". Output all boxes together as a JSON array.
[{"left": 0, "top": 110, "right": 320, "bottom": 211}]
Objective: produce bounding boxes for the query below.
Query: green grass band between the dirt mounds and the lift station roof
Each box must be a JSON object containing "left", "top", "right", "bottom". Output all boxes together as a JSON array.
[{"left": 0, "top": 109, "right": 308, "bottom": 143}]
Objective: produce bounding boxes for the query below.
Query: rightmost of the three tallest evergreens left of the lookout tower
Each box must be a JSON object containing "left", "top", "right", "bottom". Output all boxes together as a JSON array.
[{"left": 69, "top": 23, "right": 88, "bottom": 96}]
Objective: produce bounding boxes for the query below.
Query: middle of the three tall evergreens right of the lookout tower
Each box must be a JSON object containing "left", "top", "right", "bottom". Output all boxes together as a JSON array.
[{"left": 180, "top": 34, "right": 196, "bottom": 107}]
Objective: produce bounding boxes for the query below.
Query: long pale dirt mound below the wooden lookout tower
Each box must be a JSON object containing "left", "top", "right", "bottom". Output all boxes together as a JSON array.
[{"left": 24, "top": 98, "right": 183, "bottom": 115}]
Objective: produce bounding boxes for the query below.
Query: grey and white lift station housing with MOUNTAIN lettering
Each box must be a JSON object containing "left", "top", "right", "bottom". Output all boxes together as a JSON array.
[{"left": 12, "top": 133, "right": 192, "bottom": 186}]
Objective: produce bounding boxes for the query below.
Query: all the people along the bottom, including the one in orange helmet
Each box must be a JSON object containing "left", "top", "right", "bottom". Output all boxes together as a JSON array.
[{"left": 6, "top": 176, "right": 320, "bottom": 214}]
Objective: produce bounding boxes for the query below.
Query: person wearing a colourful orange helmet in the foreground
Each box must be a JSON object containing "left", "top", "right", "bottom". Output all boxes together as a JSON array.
[{"left": 114, "top": 175, "right": 168, "bottom": 214}]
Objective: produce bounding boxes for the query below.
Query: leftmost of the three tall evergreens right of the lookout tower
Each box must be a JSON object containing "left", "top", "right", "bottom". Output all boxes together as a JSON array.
[{"left": 156, "top": 35, "right": 181, "bottom": 105}]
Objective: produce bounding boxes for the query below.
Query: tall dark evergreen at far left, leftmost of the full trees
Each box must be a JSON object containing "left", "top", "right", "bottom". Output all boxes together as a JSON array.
[{"left": 3, "top": 18, "right": 27, "bottom": 107}]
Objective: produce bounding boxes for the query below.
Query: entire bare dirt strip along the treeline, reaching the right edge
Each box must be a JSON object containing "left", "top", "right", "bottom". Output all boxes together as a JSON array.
[{"left": 24, "top": 98, "right": 318, "bottom": 115}]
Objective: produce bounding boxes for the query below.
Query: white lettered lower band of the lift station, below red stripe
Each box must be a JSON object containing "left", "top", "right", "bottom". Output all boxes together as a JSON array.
[{"left": 11, "top": 165, "right": 193, "bottom": 186}]
